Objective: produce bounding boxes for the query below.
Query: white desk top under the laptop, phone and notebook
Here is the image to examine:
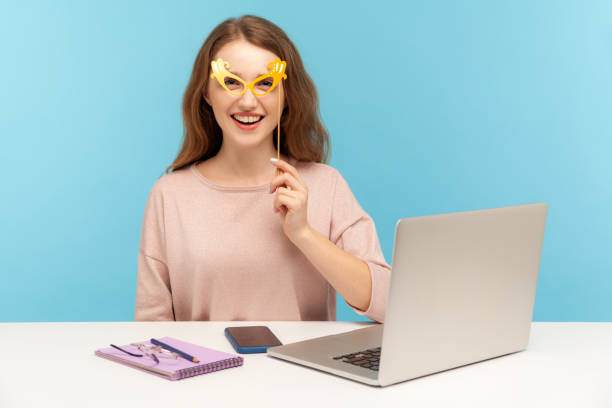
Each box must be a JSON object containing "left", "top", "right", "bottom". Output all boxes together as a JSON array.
[{"left": 0, "top": 322, "right": 612, "bottom": 408}]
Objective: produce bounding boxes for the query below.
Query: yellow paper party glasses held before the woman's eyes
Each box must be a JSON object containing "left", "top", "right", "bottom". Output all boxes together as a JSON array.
[{"left": 210, "top": 58, "right": 287, "bottom": 96}]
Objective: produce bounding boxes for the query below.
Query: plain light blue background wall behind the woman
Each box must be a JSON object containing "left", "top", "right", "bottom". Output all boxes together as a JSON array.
[{"left": 0, "top": 1, "right": 612, "bottom": 321}]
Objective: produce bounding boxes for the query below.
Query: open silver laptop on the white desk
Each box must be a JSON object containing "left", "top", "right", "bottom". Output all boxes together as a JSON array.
[{"left": 267, "top": 203, "right": 548, "bottom": 386}]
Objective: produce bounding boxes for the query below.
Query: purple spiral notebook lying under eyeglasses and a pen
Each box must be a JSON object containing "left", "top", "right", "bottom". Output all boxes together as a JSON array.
[{"left": 96, "top": 337, "right": 243, "bottom": 380}]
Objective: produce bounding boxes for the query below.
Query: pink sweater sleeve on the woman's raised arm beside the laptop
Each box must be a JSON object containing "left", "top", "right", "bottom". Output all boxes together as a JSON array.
[{"left": 330, "top": 171, "right": 391, "bottom": 323}]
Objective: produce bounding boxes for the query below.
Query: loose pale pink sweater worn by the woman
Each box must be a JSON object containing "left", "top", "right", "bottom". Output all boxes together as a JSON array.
[{"left": 135, "top": 159, "right": 391, "bottom": 322}]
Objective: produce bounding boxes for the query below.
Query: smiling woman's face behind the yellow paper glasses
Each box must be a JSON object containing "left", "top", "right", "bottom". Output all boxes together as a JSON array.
[{"left": 205, "top": 40, "right": 285, "bottom": 150}]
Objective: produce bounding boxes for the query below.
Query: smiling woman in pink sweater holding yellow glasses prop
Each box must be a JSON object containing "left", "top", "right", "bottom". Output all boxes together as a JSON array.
[{"left": 135, "top": 16, "right": 390, "bottom": 322}]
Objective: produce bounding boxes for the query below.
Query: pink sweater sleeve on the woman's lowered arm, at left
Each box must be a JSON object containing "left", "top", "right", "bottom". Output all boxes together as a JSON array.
[{"left": 134, "top": 180, "right": 174, "bottom": 321}]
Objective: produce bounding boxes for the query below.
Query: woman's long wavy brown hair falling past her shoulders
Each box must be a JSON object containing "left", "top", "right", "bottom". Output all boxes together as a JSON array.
[{"left": 166, "top": 15, "right": 329, "bottom": 173}]
